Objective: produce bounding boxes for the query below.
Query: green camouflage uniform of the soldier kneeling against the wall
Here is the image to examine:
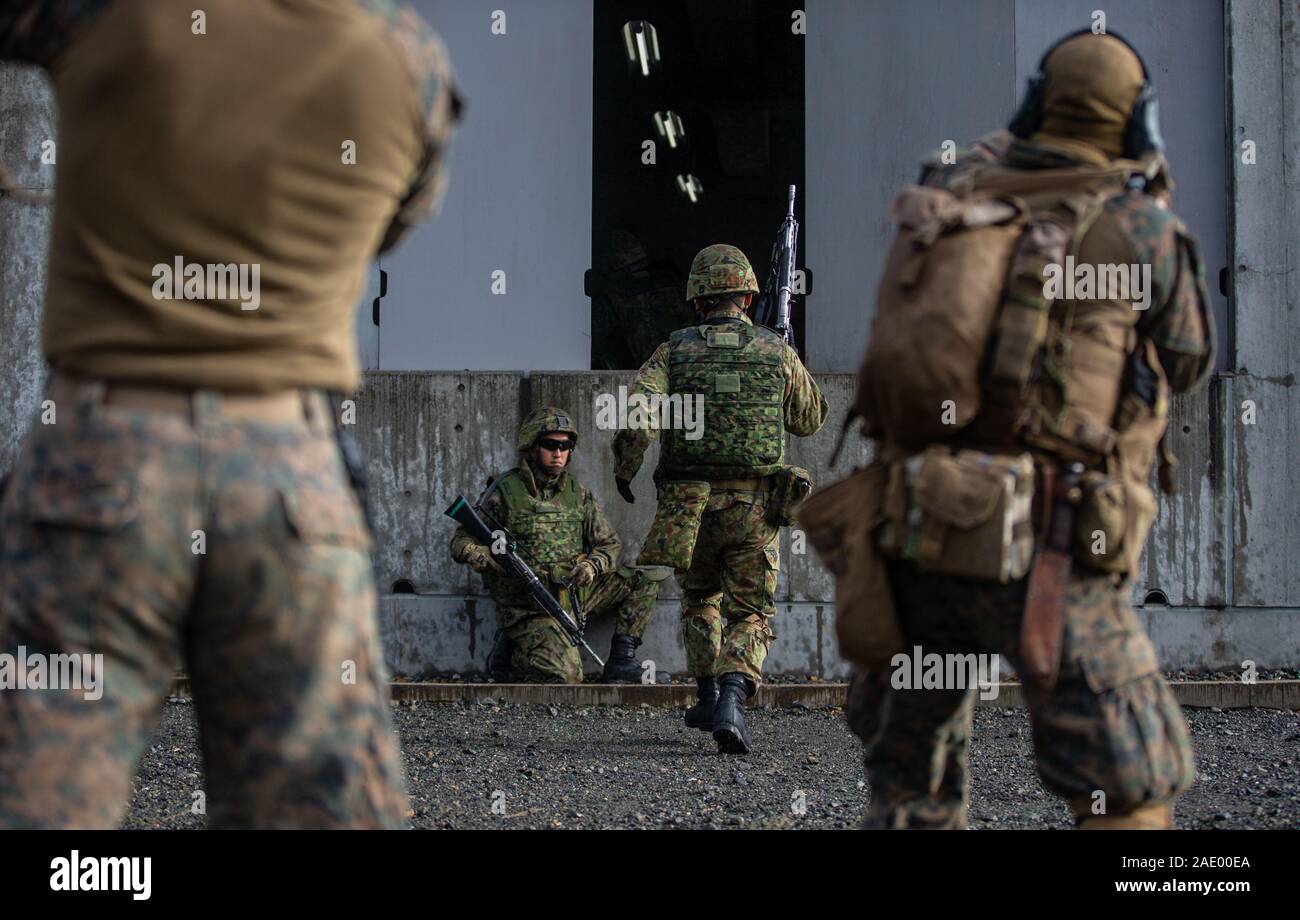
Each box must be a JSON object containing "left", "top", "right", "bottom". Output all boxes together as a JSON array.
[{"left": 451, "top": 460, "right": 659, "bottom": 684}]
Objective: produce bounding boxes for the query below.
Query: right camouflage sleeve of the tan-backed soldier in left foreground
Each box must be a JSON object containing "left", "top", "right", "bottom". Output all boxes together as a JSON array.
[{"left": 365, "top": 0, "right": 464, "bottom": 252}]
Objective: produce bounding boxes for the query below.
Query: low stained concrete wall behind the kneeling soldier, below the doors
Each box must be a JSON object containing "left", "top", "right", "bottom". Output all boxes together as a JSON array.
[{"left": 356, "top": 372, "right": 1300, "bottom": 680}]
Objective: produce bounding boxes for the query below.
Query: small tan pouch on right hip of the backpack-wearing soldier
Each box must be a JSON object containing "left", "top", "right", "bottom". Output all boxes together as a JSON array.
[{"left": 1074, "top": 472, "right": 1157, "bottom": 578}]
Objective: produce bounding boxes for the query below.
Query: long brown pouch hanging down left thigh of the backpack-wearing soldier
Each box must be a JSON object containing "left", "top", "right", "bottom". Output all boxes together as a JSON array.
[{"left": 794, "top": 465, "right": 904, "bottom": 667}]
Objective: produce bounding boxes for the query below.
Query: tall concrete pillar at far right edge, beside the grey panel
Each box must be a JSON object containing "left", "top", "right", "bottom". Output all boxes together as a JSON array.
[{"left": 1223, "top": 0, "right": 1300, "bottom": 607}]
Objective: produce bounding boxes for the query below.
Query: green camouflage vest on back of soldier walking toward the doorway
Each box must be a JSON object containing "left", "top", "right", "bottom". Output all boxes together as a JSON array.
[{"left": 660, "top": 321, "right": 787, "bottom": 479}]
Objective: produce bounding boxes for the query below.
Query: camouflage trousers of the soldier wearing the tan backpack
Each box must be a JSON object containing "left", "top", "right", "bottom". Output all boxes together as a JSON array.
[{"left": 846, "top": 563, "right": 1195, "bottom": 828}]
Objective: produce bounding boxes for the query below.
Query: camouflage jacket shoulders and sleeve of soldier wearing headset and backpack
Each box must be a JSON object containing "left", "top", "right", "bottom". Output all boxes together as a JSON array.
[{"left": 920, "top": 131, "right": 1214, "bottom": 392}]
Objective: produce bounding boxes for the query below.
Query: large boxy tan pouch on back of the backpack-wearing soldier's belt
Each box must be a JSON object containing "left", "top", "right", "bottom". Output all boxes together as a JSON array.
[{"left": 879, "top": 446, "right": 1034, "bottom": 585}]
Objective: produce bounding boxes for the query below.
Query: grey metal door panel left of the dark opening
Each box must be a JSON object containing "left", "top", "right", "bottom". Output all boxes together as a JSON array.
[{"left": 369, "top": 0, "right": 592, "bottom": 370}]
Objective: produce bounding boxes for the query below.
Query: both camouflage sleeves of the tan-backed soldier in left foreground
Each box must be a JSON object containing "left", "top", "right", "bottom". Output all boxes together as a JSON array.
[{"left": 0, "top": 0, "right": 463, "bottom": 251}]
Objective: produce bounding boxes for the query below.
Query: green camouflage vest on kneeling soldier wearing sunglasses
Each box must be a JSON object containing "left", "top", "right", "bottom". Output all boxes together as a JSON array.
[{"left": 484, "top": 470, "right": 584, "bottom": 607}]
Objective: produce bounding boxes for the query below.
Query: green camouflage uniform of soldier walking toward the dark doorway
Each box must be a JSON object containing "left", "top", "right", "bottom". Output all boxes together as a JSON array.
[{"left": 614, "top": 247, "right": 829, "bottom": 685}]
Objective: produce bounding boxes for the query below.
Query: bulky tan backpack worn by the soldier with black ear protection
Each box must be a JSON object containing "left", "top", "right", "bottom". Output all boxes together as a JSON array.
[{"left": 854, "top": 161, "right": 1138, "bottom": 451}]
